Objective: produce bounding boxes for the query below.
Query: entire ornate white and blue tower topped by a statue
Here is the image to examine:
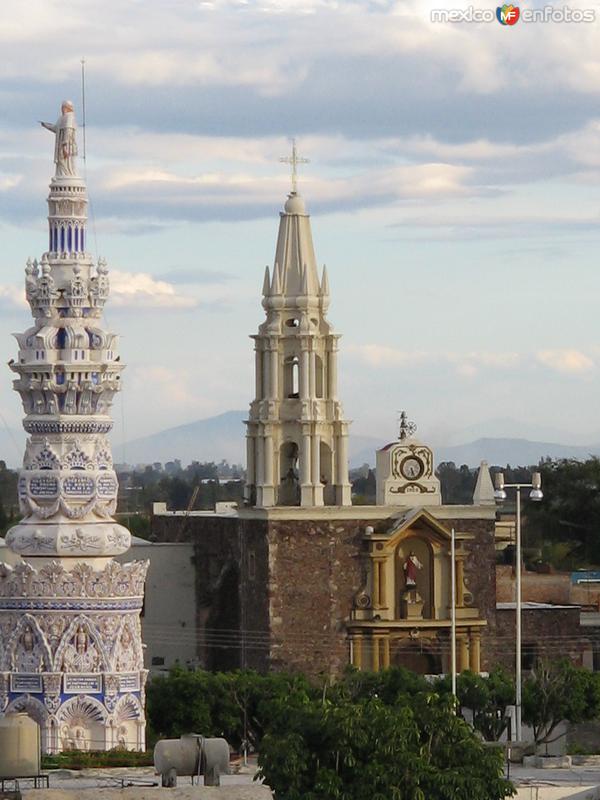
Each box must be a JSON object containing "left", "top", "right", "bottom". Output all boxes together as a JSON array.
[{"left": 0, "top": 102, "right": 147, "bottom": 752}]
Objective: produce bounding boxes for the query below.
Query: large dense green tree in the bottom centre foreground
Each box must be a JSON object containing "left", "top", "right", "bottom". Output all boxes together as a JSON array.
[{"left": 259, "top": 693, "right": 514, "bottom": 800}]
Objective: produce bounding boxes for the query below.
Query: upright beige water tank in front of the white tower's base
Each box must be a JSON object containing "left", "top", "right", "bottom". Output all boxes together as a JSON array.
[{"left": 0, "top": 714, "right": 41, "bottom": 778}]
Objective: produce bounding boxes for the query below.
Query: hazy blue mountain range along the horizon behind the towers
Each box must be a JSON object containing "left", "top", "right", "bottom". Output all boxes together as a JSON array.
[{"left": 0, "top": 411, "right": 600, "bottom": 467}]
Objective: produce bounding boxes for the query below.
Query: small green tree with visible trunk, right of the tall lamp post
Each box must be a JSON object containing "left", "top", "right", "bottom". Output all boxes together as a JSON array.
[{"left": 523, "top": 659, "right": 600, "bottom": 744}]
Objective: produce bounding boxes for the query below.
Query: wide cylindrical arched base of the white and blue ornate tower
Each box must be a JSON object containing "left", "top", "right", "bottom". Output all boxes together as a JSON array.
[{"left": 0, "top": 561, "right": 147, "bottom": 753}]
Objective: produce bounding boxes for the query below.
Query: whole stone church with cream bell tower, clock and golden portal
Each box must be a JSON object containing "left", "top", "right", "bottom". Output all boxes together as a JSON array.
[{"left": 152, "top": 180, "right": 496, "bottom": 675}]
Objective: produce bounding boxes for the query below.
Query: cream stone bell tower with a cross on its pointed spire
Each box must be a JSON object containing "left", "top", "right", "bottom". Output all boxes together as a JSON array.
[{"left": 246, "top": 148, "right": 351, "bottom": 507}]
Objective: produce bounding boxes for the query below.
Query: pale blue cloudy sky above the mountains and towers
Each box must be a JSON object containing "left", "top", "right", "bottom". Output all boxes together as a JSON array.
[{"left": 0, "top": 0, "right": 600, "bottom": 460}]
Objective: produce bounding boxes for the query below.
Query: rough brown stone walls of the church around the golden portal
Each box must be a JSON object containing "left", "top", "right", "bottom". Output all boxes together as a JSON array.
[{"left": 152, "top": 515, "right": 496, "bottom": 677}]
